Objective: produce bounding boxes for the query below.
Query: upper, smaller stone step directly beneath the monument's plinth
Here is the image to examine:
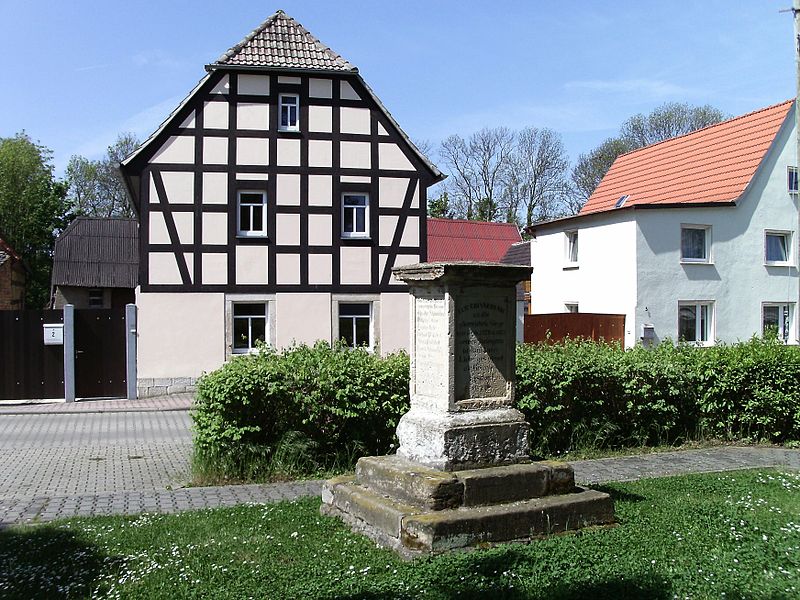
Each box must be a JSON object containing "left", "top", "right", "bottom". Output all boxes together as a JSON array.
[{"left": 356, "top": 455, "right": 575, "bottom": 510}]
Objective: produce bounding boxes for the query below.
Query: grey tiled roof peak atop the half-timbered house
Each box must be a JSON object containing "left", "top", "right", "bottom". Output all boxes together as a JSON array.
[{"left": 209, "top": 10, "right": 358, "bottom": 72}]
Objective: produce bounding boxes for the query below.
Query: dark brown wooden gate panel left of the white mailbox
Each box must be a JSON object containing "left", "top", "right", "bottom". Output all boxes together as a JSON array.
[{"left": 0, "top": 310, "right": 65, "bottom": 400}]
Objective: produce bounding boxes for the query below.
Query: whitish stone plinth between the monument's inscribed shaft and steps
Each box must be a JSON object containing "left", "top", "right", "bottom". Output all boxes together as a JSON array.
[{"left": 397, "top": 406, "right": 530, "bottom": 471}]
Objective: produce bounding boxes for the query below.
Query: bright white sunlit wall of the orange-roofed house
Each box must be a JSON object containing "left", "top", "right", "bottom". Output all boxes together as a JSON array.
[{"left": 531, "top": 216, "right": 636, "bottom": 346}]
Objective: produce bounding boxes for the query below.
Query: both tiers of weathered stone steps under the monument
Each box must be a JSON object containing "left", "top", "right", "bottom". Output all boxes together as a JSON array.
[{"left": 321, "top": 456, "right": 614, "bottom": 558}]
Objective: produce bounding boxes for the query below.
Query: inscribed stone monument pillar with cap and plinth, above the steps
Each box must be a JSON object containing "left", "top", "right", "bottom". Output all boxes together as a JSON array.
[{"left": 394, "top": 263, "right": 531, "bottom": 471}]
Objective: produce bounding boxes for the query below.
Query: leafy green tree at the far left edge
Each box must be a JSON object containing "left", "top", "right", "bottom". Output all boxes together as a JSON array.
[{"left": 0, "top": 132, "right": 71, "bottom": 308}]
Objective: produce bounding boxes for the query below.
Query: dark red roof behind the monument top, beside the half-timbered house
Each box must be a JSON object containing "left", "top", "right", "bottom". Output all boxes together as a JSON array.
[{"left": 428, "top": 218, "right": 522, "bottom": 262}]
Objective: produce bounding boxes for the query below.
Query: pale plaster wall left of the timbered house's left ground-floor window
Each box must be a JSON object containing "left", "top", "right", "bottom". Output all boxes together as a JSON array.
[{"left": 136, "top": 290, "right": 225, "bottom": 378}]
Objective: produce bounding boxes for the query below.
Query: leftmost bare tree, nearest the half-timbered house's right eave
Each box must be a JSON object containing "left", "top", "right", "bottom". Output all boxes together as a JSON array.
[{"left": 439, "top": 127, "right": 515, "bottom": 221}]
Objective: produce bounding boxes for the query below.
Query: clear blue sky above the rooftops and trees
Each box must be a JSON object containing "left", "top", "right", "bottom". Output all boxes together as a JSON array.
[{"left": 0, "top": 0, "right": 795, "bottom": 174}]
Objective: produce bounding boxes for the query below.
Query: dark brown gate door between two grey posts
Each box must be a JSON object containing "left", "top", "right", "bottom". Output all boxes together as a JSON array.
[{"left": 75, "top": 307, "right": 126, "bottom": 398}]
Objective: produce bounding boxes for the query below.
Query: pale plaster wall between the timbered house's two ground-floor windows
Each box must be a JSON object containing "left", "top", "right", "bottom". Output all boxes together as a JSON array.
[{"left": 275, "top": 293, "right": 331, "bottom": 348}]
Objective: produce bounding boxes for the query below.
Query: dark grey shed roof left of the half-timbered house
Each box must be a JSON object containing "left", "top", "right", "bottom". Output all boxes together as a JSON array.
[{"left": 52, "top": 217, "right": 139, "bottom": 288}]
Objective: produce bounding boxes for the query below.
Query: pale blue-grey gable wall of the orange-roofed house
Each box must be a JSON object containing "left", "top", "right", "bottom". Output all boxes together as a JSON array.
[{"left": 636, "top": 116, "right": 800, "bottom": 343}]
